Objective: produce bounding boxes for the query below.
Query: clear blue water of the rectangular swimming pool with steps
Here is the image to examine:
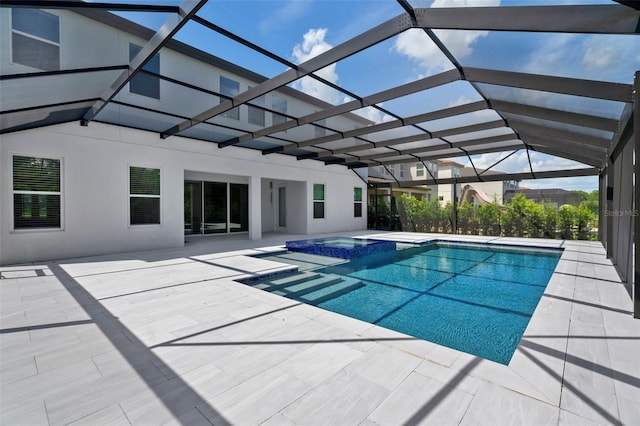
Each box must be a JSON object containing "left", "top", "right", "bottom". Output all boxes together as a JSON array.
[{"left": 246, "top": 242, "right": 562, "bottom": 364}]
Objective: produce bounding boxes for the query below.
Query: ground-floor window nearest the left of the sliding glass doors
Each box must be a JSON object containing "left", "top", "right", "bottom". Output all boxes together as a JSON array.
[{"left": 129, "top": 166, "right": 160, "bottom": 225}]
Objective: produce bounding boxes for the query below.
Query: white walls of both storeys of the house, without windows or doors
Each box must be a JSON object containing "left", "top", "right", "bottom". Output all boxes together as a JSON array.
[{"left": 0, "top": 8, "right": 371, "bottom": 264}]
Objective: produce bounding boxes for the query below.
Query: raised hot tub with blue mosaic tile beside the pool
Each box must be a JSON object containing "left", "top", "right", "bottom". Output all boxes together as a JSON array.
[{"left": 286, "top": 237, "right": 396, "bottom": 259}]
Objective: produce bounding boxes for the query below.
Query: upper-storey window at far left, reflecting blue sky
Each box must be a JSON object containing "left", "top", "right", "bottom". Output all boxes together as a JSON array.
[{"left": 11, "top": 8, "right": 60, "bottom": 71}]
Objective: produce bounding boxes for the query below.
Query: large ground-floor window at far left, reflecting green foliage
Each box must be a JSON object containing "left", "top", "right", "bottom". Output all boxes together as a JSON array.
[{"left": 13, "top": 155, "right": 62, "bottom": 229}]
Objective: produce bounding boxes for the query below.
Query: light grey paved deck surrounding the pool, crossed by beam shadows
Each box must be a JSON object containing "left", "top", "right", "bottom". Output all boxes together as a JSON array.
[{"left": 0, "top": 231, "right": 640, "bottom": 426}]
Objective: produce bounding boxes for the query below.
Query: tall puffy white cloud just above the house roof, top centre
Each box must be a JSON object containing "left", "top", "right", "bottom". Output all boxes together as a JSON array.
[{"left": 292, "top": 28, "right": 343, "bottom": 105}]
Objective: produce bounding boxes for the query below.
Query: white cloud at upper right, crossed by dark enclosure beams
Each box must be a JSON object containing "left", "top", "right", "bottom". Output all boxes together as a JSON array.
[{"left": 394, "top": 0, "right": 500, "bottom": 74}]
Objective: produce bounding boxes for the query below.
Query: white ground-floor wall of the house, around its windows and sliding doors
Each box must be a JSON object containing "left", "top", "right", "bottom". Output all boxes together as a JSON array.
[{"left": 0, "top": 123, "right": 366, "bottom": 264}]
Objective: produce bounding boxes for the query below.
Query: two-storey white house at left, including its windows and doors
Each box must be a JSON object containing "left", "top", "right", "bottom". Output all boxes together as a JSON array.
[{"left": 0, "top": 8, "right": 371, "bottom": 264}]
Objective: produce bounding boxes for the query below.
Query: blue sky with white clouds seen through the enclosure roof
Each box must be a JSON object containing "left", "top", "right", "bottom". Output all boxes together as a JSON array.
[{"left": 116, "top": 0, "right": 640, "bottom": 191}]
